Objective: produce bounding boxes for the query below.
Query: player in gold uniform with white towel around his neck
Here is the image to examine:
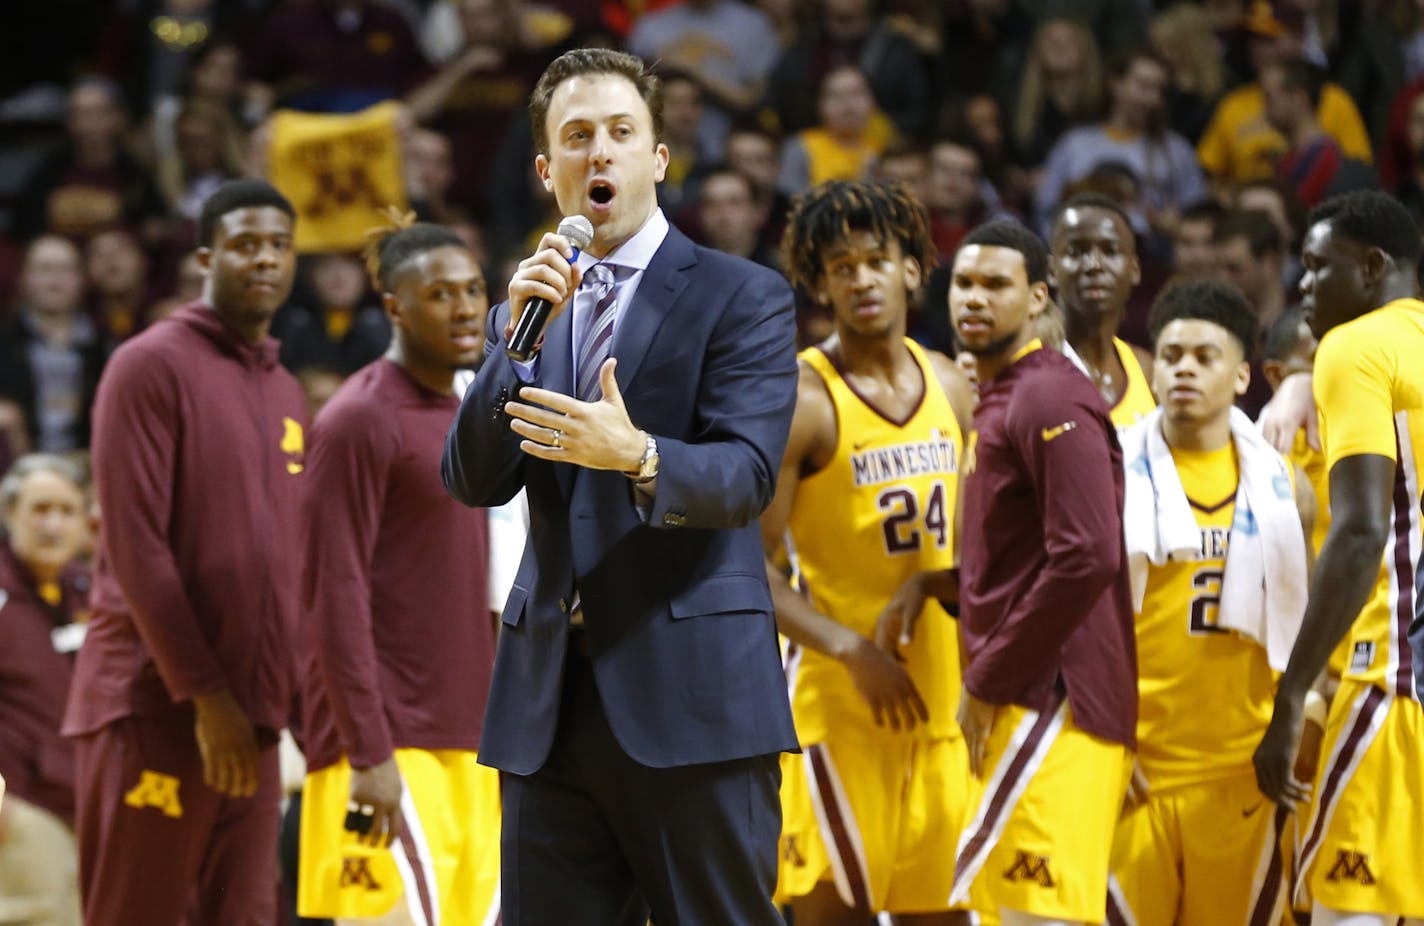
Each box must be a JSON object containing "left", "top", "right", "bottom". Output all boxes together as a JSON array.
[{"left": 1108, "top": 281, "right": 1314, "bottom": 926}]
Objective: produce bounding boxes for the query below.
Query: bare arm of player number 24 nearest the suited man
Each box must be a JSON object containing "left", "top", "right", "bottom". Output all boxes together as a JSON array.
[{"left": 762, "top": 365, "right": 928, "bottom": 729}]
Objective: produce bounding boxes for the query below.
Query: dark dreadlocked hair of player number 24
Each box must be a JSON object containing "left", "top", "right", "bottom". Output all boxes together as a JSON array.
[{"left": 782, "top": 180, "right": 936, "bottom": 291}]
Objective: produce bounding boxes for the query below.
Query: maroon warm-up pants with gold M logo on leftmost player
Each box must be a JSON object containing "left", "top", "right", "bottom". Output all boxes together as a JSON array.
[{"left": 74, "top": 714, "right": 282, "bottom": 926}]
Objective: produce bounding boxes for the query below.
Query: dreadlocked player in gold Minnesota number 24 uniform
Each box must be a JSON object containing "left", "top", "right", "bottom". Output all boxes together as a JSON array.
[{"left": 762, "top": 176, "right": 974, "bottom": 926}]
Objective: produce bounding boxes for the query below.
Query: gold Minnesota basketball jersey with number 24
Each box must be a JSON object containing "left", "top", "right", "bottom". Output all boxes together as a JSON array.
[{"left": 787, "top": 339, "right": 964, "bottom": 744}]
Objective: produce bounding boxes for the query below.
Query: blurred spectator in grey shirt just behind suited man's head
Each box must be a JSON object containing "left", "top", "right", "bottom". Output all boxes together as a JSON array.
[{"left": 627, "top": 0, "right": 780, "bottom": 152}]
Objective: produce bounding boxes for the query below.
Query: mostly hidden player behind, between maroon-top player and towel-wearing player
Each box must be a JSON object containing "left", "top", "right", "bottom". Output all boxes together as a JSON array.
[{"left": 1048, "top": 192, "right": 1156, "bottom": 429}]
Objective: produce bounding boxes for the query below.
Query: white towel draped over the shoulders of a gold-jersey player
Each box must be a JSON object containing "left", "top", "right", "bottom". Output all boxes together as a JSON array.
[{"left": 1122, "top": 409, "right": 1306, "bottom": 671}]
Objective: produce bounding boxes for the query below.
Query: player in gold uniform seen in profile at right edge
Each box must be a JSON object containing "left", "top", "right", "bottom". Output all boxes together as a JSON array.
[{"left": 1256, "top": 192, "right": 1424, "bottom": 926}]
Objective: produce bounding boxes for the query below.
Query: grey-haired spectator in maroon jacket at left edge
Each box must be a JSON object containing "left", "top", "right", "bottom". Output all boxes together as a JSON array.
[{"left": 0, "top": 454, "right": 88, "bottom": 926}]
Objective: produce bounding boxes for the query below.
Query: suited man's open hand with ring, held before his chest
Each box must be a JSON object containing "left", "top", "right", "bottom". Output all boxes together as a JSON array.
[{"left": 504, "top": 358, "right": 648, "bottom": 473}]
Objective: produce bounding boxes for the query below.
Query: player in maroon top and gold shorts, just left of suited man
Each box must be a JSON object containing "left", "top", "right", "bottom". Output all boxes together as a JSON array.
[{"left": 298, "top": 214, "right": 500, "bottom": 926}]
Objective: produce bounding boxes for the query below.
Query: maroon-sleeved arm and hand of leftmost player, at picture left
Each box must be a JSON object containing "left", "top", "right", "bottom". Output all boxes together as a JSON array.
[{"left": 93, "top": 350, "right": 258, "bottom": 798}]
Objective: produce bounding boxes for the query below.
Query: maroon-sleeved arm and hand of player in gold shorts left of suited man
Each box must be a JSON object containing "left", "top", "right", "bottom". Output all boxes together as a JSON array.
[{"left": 302, "top": 405, "right": 402, "bottom": 846}]
